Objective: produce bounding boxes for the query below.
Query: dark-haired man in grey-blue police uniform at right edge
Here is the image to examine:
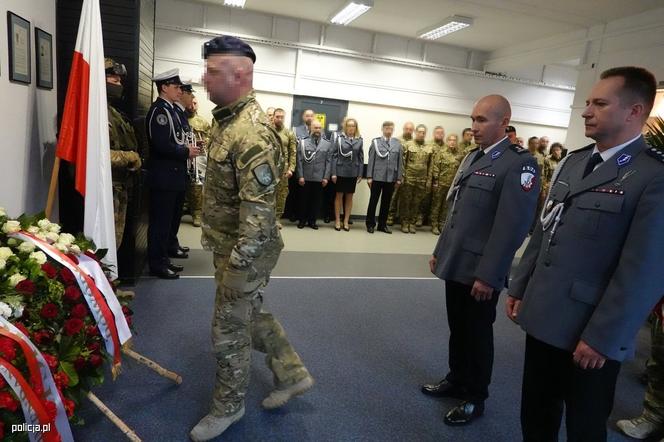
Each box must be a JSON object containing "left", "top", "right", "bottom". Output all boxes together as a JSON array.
[{"left": 507, "top": 67, "right": 664, "bottom": 442}]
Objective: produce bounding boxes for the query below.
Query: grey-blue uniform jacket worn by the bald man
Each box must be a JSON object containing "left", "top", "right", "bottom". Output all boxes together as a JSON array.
[{"left": 433, "top": 139, "right": 540, "bottom": 290}]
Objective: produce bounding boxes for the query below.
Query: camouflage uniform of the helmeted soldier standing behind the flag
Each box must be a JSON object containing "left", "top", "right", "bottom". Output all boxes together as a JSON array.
[{"left": 108, "top": 105, "right": 141, "bottom": 247}]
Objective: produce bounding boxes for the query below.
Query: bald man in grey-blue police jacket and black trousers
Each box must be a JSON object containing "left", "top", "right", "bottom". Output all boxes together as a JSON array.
[{"left": 422, "top": 95, "right": 538, "bottom": 425}]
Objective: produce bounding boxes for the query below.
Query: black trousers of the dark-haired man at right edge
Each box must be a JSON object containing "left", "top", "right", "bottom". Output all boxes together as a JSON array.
[{"left": 521, "top": 335, "right": 620, "bottom": 442}]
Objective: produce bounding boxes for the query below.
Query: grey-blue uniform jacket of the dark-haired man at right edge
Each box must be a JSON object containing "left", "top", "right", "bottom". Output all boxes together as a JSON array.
[{"left": 509, "top": 138, "right": 664, "bottom": 361}]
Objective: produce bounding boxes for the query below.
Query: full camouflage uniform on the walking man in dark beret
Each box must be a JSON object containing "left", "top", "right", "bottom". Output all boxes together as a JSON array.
[{"left": 201, "top": 91, "right": 309, "bottom": 416}]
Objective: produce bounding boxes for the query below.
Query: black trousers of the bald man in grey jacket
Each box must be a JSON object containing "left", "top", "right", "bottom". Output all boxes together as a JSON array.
[{"left": 445, "top": 281, "right": 500, "bottom": 402}]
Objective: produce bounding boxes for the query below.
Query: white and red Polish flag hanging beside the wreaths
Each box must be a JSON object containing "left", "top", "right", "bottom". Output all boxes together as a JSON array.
[{"left": 55, "top": 0, "right": 118, "bottom": 279}]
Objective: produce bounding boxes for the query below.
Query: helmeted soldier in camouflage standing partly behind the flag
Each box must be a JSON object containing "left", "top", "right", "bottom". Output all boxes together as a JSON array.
[{"left": 104, "top": 58, "right": 142, "bottom": 297}]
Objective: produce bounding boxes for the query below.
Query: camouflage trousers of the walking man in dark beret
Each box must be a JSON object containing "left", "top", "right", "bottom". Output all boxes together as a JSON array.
[{"left": 212, "top": 253, "right": 309, "bottom": 415}]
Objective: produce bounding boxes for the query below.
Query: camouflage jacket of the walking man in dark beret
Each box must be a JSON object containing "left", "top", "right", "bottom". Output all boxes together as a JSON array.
[{"left": 201, "top": 91, "right": 283, "bottom": 281}]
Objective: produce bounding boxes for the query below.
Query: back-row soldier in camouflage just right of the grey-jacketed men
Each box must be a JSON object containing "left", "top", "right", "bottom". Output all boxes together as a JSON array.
[{"left": 399, "top": 124, "right": 433, "bottom": 233}]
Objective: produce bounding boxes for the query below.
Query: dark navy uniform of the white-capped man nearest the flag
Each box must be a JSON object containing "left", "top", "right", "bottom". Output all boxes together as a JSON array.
[{"left": 145, "top": 98, "right": 189, "bottom": 271}]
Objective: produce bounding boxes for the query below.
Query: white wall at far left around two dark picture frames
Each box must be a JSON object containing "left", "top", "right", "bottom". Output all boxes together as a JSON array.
[{"left": 0, "top": 0, "right": 57, "bottom": 216}]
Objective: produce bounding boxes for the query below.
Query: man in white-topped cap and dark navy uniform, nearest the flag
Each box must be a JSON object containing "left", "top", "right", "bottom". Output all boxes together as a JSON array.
[{"left": 145, "top": 69, "right": 199, "bottom": 279}]
